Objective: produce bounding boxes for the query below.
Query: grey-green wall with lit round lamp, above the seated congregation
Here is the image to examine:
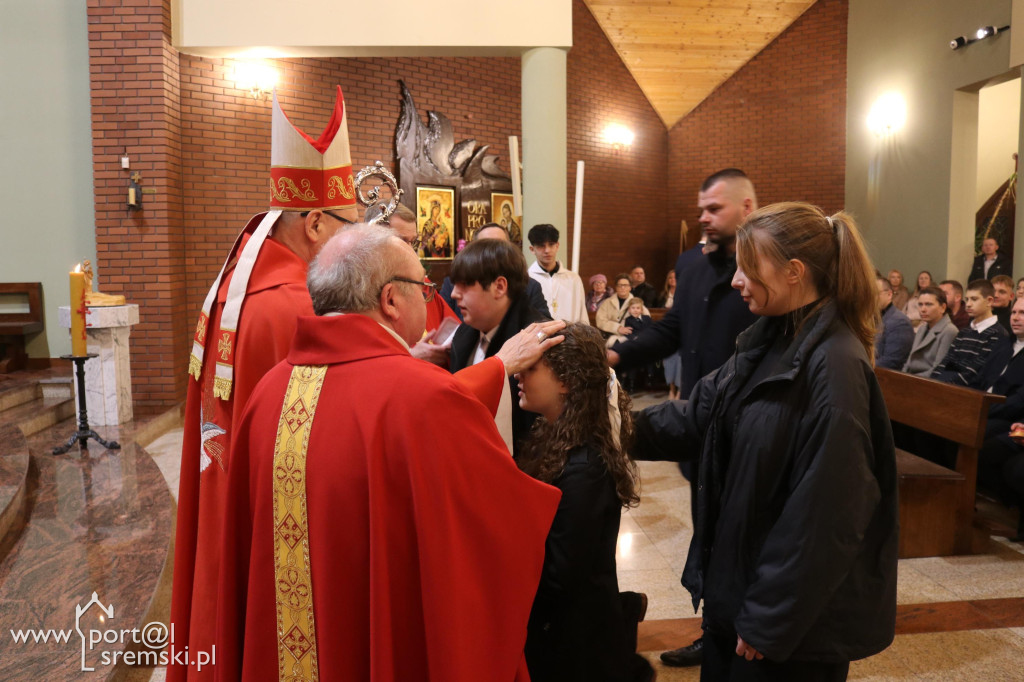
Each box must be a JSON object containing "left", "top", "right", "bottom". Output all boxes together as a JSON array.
[{"left": 846, "top": 0, "right": 1011, "bottom": 282}]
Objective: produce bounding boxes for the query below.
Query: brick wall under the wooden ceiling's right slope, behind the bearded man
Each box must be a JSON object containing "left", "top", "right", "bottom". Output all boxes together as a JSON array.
[{"left": 669, "top": 0, "right": 848, "bottom": 242}]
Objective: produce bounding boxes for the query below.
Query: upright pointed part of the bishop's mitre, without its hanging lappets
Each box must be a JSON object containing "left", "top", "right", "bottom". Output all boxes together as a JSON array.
[{"left": 270, "top": 86, "right": 355, "bottom": 211}]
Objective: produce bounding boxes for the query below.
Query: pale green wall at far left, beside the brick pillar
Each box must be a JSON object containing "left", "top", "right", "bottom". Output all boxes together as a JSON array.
[{"left": 0, "top": 0, "right": 96, "bottom": 357}]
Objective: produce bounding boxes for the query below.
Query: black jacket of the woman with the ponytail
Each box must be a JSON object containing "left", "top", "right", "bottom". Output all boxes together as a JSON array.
[{"left": 634, "top": 303, "right": 899, "bottom": 662}]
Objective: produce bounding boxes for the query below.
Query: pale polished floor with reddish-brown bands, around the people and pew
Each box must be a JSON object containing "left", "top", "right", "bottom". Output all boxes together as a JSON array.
[{"left": 146, "top": 393, "right": 1024, "bottom": 682}]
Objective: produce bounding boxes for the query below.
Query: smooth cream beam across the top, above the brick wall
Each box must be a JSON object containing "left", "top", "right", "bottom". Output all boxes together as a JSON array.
[{"left": 171, "top": 0, "right": 572, "bottom": 56}]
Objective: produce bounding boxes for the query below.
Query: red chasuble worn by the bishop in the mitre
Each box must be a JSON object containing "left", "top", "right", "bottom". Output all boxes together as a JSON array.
[{"left": 167, "top": 236, "right": 312, "bottom": 680}]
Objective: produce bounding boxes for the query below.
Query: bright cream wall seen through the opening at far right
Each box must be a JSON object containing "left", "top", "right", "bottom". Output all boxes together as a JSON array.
[{"left": 975, "top": 78, "right": 1021, "bottom": 210}]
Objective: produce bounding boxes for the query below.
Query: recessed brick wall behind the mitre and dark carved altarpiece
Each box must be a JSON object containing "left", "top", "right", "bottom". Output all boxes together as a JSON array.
[{"left": 180, "top": 54, "right": 521, "bottom": 314}]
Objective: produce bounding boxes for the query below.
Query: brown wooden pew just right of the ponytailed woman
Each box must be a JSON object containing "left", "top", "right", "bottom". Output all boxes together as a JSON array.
[{"left": 874, "top": 368, "right": 1006, "bottom": 558}]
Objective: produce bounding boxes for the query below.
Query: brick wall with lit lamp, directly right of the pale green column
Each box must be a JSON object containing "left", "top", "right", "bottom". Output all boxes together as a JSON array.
[{"left": 566, "top": 0, "right": 679, "bottom": 289}]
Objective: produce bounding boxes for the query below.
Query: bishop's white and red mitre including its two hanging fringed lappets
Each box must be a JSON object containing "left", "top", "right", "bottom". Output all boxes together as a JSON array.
[{"left": 188, "top": 86, "right": 355, "bottom": 400}]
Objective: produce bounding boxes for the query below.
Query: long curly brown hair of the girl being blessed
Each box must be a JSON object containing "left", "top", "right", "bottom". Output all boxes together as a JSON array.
[{"left": 519, "top": 324, "right": 640, "bottom": 507}]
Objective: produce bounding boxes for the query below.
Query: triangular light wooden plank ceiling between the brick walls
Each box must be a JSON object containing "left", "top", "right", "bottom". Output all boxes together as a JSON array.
[{"left": 584, "top": 0, "right": 814, "bottom": 128}]
